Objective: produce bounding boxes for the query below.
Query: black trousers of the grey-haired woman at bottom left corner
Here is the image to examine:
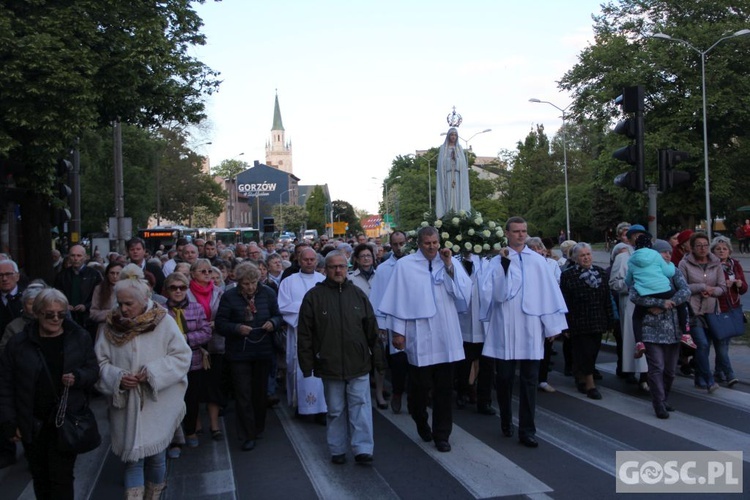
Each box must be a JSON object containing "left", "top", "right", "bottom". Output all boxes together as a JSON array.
[{"left": 23, "top": 423, "right": 78, "bottom": 500}]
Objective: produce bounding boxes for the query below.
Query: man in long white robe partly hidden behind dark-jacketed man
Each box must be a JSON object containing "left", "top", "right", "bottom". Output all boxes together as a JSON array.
[{"left": 279, "top": 247, "right": 328, "bottom": 415}]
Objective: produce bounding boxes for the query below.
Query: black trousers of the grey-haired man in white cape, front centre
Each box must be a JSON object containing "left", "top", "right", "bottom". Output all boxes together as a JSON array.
[{"left": 408, "top": 363, "right": 454, "bottom": 441}]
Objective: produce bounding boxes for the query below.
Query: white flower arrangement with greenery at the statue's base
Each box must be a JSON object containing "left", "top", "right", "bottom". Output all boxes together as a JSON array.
[{"left": 408, "top": 210, "right": 508, "bottom": 256}]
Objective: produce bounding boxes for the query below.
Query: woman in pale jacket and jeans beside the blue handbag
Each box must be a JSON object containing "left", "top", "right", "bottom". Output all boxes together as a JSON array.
[{"left": 673, "top": 233, "right": 727, "bottom": 392}]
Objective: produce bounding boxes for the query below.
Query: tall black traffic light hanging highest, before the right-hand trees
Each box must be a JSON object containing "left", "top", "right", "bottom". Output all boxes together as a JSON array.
[{"left": 612, "top": 85, "right": 646, "bottom": 192}]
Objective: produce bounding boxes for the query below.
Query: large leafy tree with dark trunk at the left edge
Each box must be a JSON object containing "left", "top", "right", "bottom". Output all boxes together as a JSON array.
[{"left": 0, "top": 0, "right": 219, "bottom": 280}]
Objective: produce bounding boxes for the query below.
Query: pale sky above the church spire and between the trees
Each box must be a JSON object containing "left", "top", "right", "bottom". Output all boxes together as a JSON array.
[{"left": 191, "top": 0, "right": 601, "bottom": 213}]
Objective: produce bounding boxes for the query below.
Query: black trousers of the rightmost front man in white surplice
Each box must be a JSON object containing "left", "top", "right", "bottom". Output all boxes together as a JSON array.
[{"left": 495, "top": 359, "right": 539, "bottom": 438}]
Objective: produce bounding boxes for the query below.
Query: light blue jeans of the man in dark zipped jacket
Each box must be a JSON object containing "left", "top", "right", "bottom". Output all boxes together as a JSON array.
[{"left": 323, "top": 374, "right": 375, "bottom": 455}]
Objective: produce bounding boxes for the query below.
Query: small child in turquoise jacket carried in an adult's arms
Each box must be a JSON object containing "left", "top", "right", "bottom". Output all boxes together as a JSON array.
[{"left": 625, "top": 233, "right": 695, "bottom": 359}]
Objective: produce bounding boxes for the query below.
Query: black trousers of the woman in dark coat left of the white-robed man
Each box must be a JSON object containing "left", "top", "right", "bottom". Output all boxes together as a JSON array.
[{"left": 229, "top": 359, "right": 271, "bottom": 441}]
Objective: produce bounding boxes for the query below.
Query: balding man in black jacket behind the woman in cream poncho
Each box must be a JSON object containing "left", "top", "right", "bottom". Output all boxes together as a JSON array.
[{"left": 55, "top": 245, "right": 102, "bottom": 333}]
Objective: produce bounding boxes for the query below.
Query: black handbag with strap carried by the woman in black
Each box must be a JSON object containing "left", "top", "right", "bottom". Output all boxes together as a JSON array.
[{"left": 39, "top": 350, "right": 102, "bottom": 454}]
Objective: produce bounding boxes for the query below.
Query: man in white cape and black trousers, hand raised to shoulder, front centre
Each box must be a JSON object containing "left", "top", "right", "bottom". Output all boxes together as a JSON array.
[{"left": 379, "top": 226, "right": 471, "bottom": 452}]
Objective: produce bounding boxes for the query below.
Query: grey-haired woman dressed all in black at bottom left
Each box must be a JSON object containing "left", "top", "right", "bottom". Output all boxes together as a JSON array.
[{"left": 0, "top": 288, "right": 99, "bottom": 499}]
